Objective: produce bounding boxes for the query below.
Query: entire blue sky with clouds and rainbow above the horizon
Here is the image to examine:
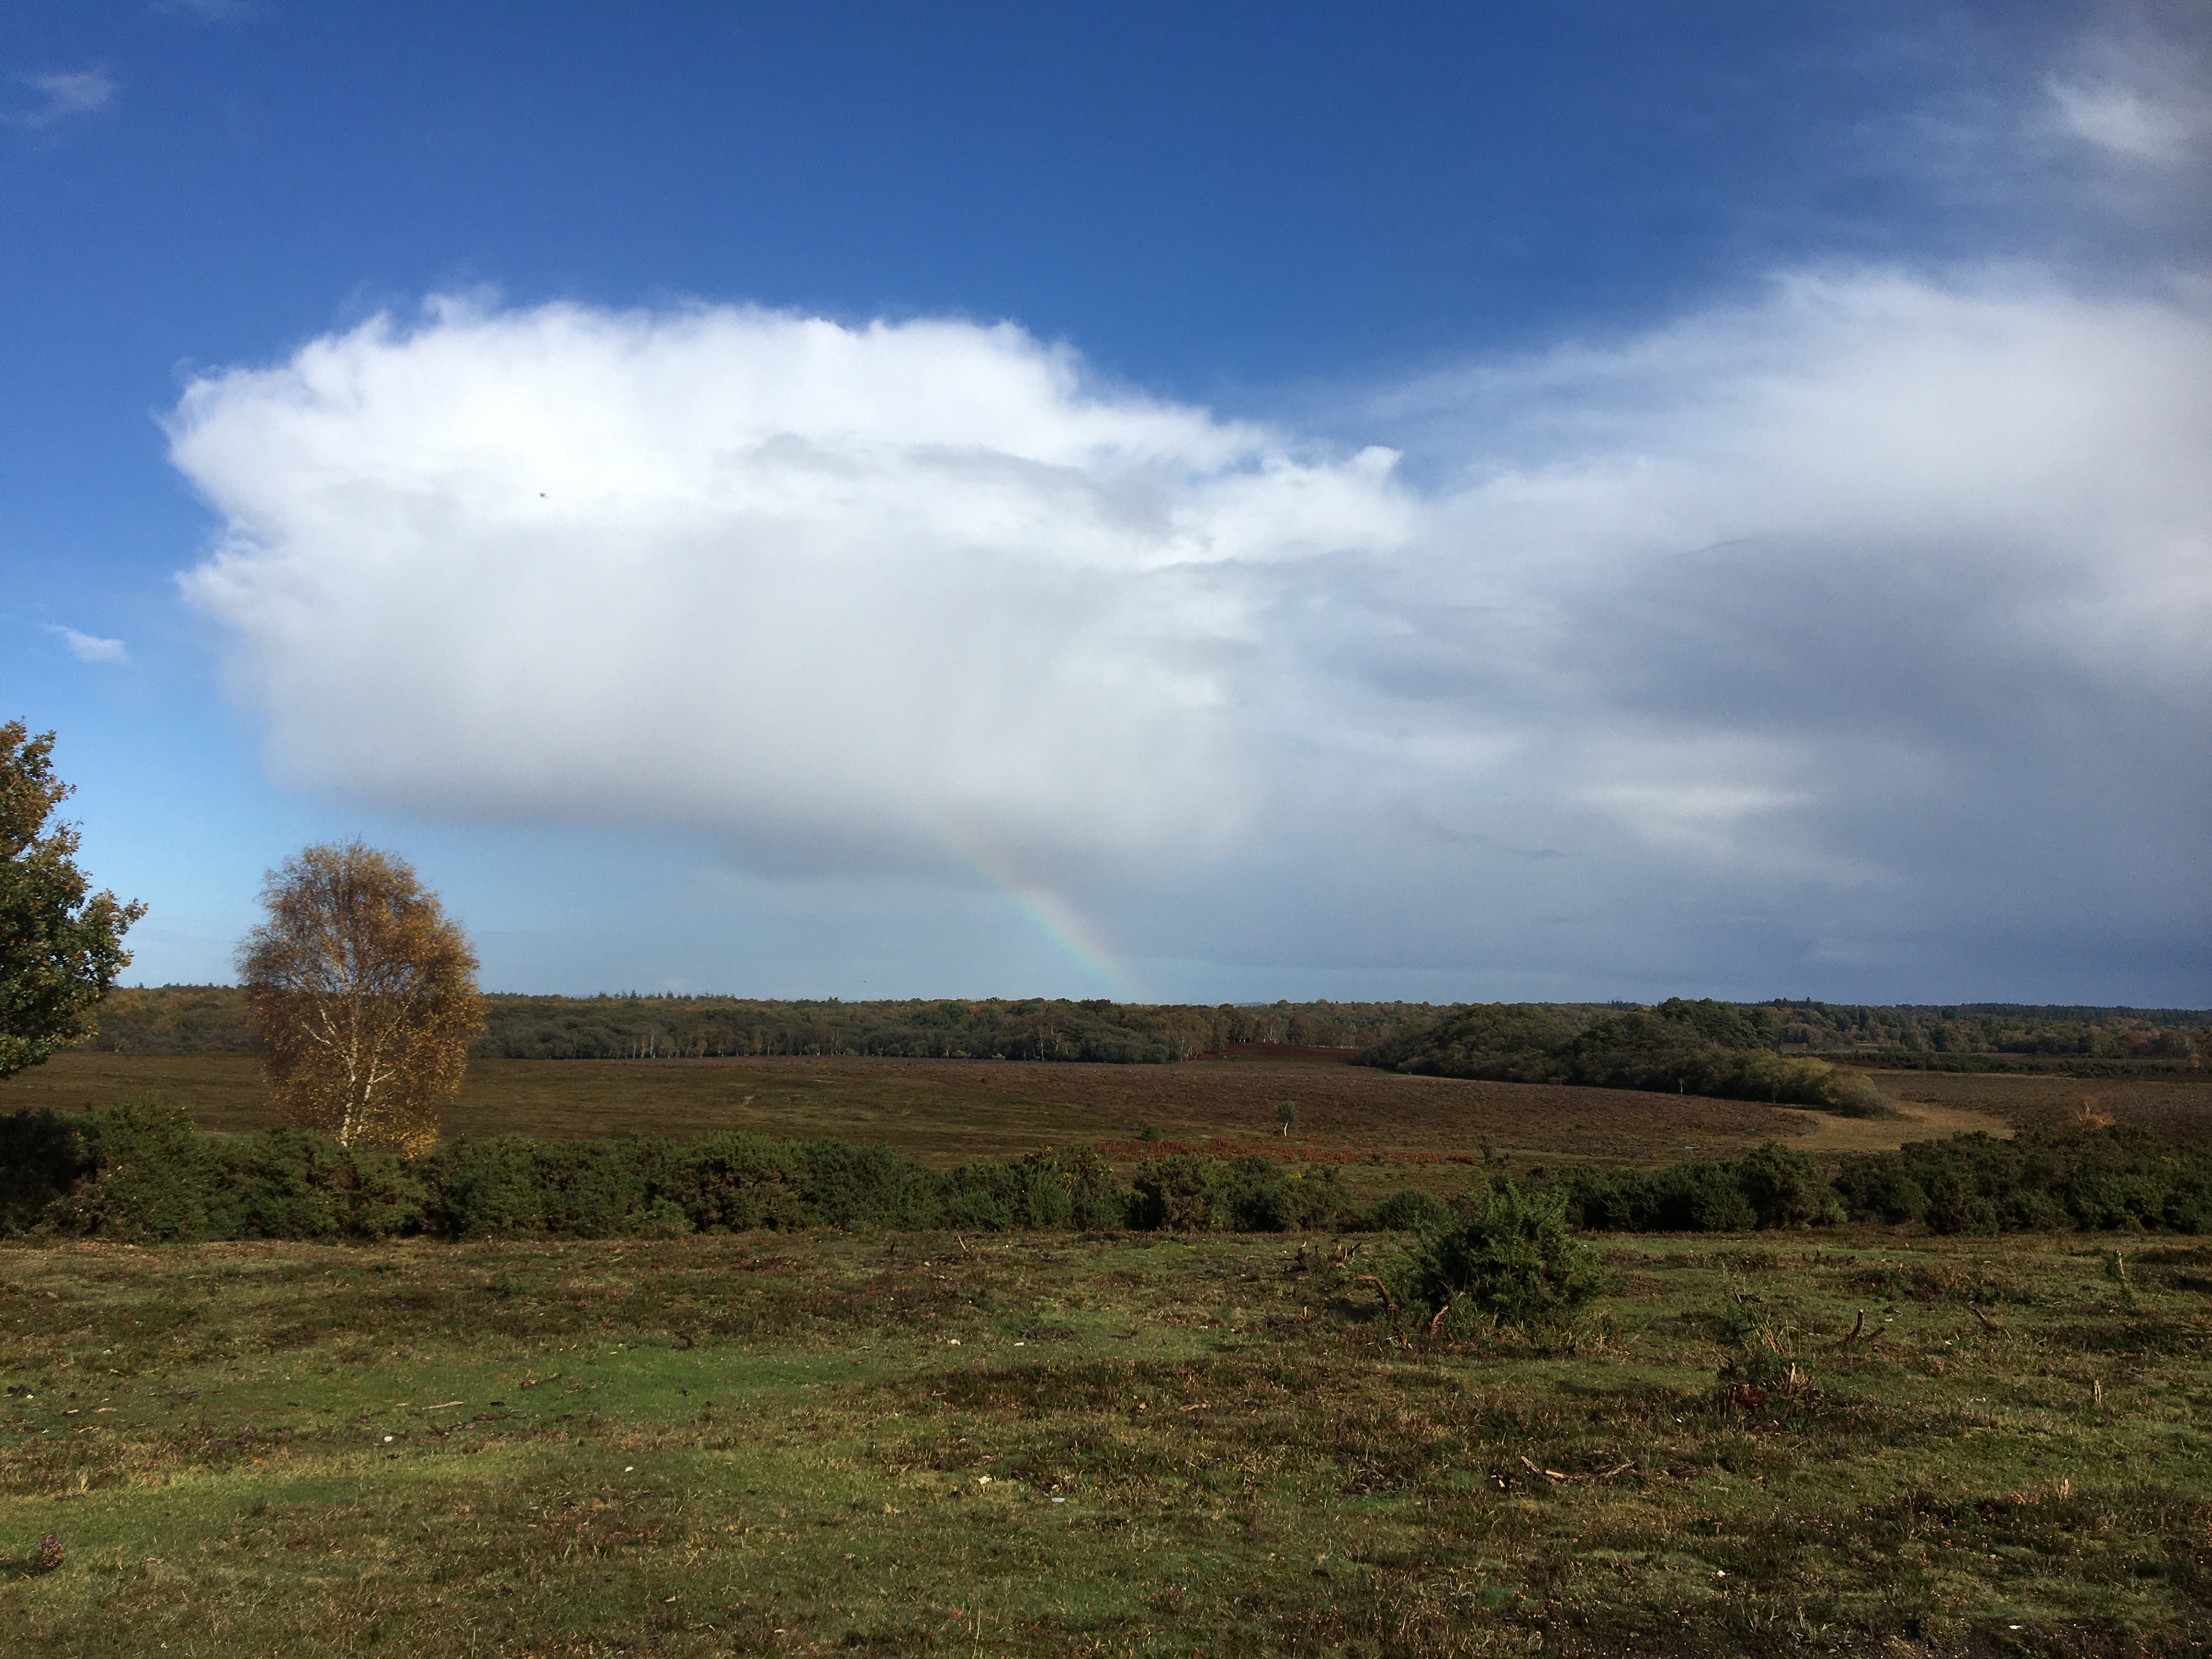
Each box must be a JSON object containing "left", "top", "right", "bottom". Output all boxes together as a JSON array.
[{"left": 0, "top": 0, "right": 2212, "bottom": 1007}]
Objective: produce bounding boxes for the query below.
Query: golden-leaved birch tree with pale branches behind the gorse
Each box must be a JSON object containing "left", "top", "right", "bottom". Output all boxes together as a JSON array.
[{"left": 239, "top": 840, "right": 484, "bottom": 1153}]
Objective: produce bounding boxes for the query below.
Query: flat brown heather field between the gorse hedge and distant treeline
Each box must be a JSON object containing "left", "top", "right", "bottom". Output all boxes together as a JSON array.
[{"left": 0, "top": 1051, "right": 2141, "bottom": 1190}]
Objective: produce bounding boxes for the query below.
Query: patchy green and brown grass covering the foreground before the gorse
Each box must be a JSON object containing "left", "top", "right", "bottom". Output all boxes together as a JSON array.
[{"left": 0, "top": 1232, "right": 2212, "bottom": 1659}]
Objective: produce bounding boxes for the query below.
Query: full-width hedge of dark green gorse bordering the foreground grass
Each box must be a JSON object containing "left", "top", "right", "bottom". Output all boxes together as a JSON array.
[{"left": 0, "top": 1102, "right": 2212, "bottom": 1243}]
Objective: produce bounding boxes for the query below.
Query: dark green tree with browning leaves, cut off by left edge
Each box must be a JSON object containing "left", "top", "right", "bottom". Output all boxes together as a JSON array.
[{"left": 0, "top": 721, "right": 146, "bottom": 1077}]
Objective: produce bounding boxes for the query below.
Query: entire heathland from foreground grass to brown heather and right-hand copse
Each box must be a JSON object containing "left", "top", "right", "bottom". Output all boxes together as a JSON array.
[{"left": 0, "top": 993, "right": 2212, "bottom": 1659}]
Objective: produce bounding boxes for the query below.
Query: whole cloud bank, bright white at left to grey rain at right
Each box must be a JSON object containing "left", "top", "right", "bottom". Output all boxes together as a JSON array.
[{"left": 172, "top": 272, "right": 2212, "bottom": 993}]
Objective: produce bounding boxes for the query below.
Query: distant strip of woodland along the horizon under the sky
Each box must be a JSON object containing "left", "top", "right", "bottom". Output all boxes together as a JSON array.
[{"left": 91, "top": 984, "right": 2212, "bottom": 1070}]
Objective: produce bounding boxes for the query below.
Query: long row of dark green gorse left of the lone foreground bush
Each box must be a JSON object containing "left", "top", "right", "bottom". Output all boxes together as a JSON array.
[{"left": 0, "top": 1102, "right": 1358, "bottom": 1243}]
